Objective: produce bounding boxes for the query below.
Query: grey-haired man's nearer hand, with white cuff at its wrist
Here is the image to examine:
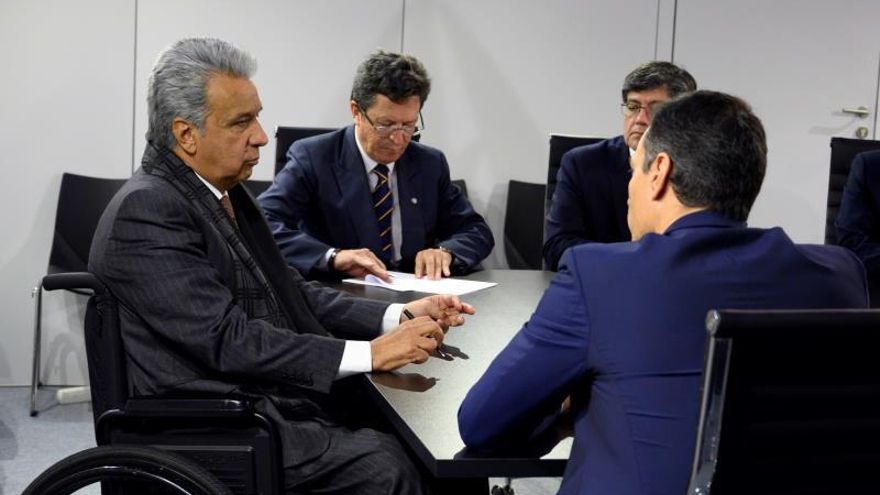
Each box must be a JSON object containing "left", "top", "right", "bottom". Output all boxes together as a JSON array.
[{"left": 370, "top": 317, "right": 443, "bottom": 371}]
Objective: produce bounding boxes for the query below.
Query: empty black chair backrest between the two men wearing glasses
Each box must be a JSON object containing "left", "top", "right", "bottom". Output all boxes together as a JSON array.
[{"left": 504, "top": 180, "right": 546, "bottom": 270}]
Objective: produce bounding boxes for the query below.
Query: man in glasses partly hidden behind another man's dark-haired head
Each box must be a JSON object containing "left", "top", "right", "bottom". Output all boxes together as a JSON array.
[{"left": 544, "top": 61, "right": 697, "bottom": 270}]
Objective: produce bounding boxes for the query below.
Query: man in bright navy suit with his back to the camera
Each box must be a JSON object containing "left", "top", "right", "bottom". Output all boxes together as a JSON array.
[{"left": 458, "top": 91, "right": 867, "bottom": 495}]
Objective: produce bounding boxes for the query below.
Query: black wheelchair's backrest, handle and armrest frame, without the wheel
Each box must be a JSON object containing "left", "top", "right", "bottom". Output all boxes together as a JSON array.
[{"left": 30, "top": 272, "right": 283, "bottom": 495}]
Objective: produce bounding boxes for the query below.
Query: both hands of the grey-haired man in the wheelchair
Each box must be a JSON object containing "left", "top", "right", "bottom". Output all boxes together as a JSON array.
[{"left": 370, "top": 294, "right": 476, "bottom": 371}]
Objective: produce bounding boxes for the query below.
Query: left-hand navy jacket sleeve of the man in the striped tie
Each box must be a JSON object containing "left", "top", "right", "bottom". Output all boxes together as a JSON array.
[{"left": 259, "top": 143, "right": 335, "bottom": 274}]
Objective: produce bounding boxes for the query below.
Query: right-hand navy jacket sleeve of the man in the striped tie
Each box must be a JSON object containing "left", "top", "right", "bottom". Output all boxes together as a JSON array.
[{"left": 437, "top": 157, "right": 495, "bottom": 273}]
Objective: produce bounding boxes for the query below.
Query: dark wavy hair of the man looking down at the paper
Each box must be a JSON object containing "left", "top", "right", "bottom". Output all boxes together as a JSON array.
[{"left": 351, "top": 50, "right": 431, "bottom": 109}]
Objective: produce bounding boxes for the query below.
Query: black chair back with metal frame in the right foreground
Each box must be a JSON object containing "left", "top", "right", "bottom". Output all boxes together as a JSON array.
[{"left": 688, "top": 310, "right": 880, "bottom": 495}]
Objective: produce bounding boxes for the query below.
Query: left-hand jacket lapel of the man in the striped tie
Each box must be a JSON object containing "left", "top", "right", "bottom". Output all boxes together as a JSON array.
[{"left": 333, "top": 126, "right": 381, "bottom": 252}]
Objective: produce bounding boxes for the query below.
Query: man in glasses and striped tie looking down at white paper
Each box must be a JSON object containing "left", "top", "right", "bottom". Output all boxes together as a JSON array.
[{"left": 259, "top": 50, "right": 495, "bottom": 280}]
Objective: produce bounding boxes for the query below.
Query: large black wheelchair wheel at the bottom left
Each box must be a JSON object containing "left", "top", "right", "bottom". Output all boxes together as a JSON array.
[{"left": 22, "top": 445, "right": 232, "bottom": 495}]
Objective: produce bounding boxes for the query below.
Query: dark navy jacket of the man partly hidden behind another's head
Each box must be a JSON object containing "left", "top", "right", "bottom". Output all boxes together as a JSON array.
[{"left": 544, "top": 136, "right": 631, "bottom": 270}]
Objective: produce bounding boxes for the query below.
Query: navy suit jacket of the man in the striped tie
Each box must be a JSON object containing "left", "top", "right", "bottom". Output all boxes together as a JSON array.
[{"left": 259, "top": 125, "right": 495, "bottom": 274}]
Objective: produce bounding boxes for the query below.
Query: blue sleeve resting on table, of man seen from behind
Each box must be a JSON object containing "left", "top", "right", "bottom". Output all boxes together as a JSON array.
[{"left": 458, "top": 255, "right": 589, "bottom": 450}]
